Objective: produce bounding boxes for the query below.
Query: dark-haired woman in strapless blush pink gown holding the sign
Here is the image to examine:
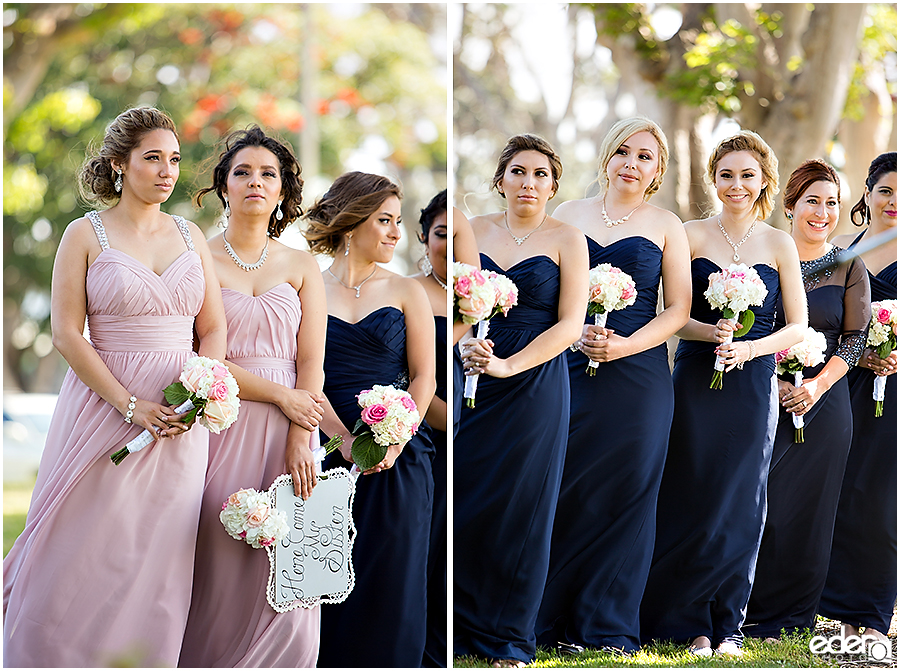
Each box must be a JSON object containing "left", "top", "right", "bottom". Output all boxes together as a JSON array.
[{"left": 179, "top": 126, "right": 326, "bottom": 667}]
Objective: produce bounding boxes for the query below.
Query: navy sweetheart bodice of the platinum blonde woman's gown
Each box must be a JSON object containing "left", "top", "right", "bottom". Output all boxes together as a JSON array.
[{"left": 585, "top": 236, "right": 662, "bottom": 337}]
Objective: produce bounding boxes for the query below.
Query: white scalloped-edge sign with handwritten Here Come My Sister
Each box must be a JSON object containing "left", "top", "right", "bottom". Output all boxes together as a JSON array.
[{"left": 266, "top": 468, "right": 356, "bottom": 613}]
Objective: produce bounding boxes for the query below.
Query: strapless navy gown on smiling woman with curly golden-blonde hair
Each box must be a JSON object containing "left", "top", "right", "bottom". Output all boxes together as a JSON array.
[{"left": 641, "top": 257, "right": 780, "bottom": 647}]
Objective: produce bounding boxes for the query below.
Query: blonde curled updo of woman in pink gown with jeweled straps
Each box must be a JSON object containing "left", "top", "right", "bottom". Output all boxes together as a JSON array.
[{"left": 78, "top": 107, "right": 180, "bottom": 206}]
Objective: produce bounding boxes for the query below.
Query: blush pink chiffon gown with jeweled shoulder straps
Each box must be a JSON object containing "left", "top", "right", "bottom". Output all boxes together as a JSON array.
[{"left": 3, "top": 212, "right": 209, "bottom": 667}]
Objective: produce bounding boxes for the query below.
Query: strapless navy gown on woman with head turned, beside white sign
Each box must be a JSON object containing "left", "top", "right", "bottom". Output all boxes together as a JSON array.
[{"left": 318, "top": 307, "right": 434, "bottom": 667}]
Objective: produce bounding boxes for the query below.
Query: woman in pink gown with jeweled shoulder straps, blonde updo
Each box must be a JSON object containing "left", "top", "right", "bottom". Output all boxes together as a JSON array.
[{"left": 3, "top": 108, "right": 225, "bottom": 667}]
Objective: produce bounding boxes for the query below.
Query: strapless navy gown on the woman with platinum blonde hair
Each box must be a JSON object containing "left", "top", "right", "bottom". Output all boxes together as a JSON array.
[{"left": 536, "top": 237, "right": 674, "bottom": 651}]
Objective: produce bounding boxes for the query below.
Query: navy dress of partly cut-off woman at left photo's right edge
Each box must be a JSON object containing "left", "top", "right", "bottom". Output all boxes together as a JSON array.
[{"left": 422, "top": 315, "right": 450, "bottom": 668}]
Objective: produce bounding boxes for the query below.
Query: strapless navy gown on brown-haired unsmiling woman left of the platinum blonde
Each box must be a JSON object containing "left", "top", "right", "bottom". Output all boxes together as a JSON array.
[{"left": 453, "top": 254, "right": 569, "bottom": 662}]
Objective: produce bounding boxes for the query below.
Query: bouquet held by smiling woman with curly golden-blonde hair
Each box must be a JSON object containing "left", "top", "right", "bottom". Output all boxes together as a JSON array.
[{"left": 703, "top": 263, "right": 769, "bottom": 389}]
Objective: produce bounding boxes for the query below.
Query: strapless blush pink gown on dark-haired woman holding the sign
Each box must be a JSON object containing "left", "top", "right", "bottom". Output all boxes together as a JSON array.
[{"left": 179, "top": 282, "right": 319, "bottom": 668}]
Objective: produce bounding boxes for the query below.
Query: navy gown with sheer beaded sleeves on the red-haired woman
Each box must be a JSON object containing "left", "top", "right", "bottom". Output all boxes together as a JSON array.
[{"left": 744, "top": 247, "right": 874, "bottom": 638}]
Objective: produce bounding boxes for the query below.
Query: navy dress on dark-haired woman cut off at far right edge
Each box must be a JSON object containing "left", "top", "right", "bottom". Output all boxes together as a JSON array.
[{"left": 819, "top": 234, "right": 897, "bottom": 634}]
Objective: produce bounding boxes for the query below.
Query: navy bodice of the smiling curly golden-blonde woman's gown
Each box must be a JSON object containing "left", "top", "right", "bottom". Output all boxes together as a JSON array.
[{"left": 675, "top": 256, "right": 781, "bottom": 375}]
